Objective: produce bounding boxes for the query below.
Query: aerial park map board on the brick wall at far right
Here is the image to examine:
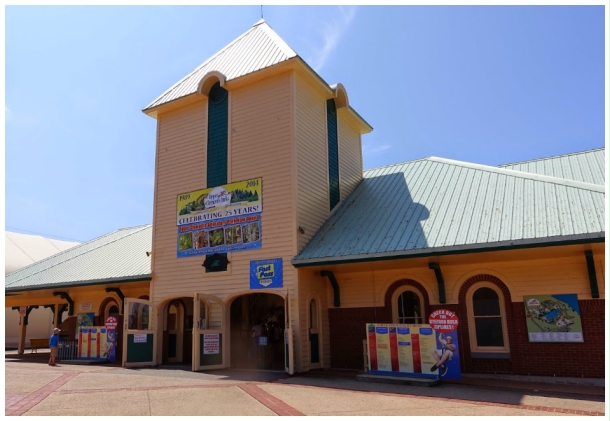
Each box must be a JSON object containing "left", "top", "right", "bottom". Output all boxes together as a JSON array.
[{"left": 523, "top": 294, "right": 584, "bottom": 342}]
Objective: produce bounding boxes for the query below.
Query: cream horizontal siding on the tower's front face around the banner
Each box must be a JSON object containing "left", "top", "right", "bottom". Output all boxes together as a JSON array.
[{"left": 153, "top": 74, "right": 296, "bottom": 302}]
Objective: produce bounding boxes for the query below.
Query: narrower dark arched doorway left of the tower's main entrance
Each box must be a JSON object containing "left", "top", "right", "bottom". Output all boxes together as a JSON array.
[{"left": 161, "top": 297, "right": 193, "bottom": 366}]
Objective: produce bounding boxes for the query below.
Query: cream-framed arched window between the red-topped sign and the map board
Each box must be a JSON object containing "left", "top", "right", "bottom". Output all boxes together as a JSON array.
[{"left": 466, "top": 282, "right": 509, "bottom": 352}]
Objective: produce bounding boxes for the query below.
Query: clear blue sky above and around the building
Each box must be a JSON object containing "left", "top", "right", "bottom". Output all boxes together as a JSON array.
[{"left": 5, "top": 6, "right": 605, "bottom": 241}]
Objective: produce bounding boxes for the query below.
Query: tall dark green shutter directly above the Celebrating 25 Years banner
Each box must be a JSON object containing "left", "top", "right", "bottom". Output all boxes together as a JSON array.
[{"left": 207, "top": 82, "right": 229, "bottom": 187}]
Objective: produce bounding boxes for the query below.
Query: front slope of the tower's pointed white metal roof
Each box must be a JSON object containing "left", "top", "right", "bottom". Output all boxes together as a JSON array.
[{"left": 144, "top": 19, "right": 297, "bottom": 111}]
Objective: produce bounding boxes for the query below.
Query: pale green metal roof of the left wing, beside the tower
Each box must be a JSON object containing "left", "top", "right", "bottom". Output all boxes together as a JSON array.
[{"left": 5, "top": 225, "right": 152, "bottom": 291}]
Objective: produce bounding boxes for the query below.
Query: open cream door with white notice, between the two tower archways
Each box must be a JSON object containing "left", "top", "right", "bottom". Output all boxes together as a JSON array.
[{"left": 192, "top": 293, "right": 227, "bottom": 371}]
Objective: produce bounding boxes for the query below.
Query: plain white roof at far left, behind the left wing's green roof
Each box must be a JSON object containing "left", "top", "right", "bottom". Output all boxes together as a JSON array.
[{"left": 4, "top": 231, "right": 79, "bottom": 275}]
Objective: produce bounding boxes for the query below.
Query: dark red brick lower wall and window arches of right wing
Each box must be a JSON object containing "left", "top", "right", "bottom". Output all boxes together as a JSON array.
[{"left": 328, "top": 277, "right": 606, "bottom": 378}]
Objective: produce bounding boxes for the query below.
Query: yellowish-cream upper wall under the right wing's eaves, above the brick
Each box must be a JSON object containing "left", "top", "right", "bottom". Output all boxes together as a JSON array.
[{"left": 326, "top": 244, "right": 605, "bottom": 308}]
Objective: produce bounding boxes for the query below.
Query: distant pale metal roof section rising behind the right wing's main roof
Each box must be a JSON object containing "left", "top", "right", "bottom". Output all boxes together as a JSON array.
[{"left": 499, "top": 148, "right": 606, "bottom": 186}]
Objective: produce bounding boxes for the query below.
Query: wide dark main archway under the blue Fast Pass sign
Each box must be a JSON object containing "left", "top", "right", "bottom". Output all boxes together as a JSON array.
[{"left": 230, "top": 293, "right": 285, "bottom": 370}]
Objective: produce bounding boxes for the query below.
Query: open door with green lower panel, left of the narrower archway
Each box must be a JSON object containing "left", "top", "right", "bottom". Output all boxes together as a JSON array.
[{"left": 123, "top": 298, "right": 157, "bottom": 367}]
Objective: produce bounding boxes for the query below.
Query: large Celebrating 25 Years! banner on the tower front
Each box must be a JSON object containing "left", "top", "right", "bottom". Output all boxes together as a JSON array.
[{"left": 176, "top": 178, "right": 263, "bottom": 257}]
